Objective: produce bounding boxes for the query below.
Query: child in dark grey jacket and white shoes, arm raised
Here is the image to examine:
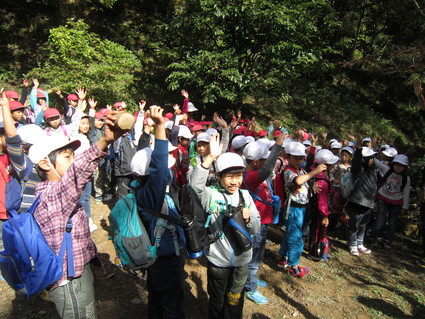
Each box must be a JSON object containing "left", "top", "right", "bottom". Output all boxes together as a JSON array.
[{"left": 347, "top": 137, "right": 378, "bottom": 256}]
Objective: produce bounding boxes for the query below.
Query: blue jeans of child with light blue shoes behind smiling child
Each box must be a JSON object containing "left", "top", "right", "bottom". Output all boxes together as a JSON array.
[{"left": 245, "top": 224, "right": 267, "bottom": 292}]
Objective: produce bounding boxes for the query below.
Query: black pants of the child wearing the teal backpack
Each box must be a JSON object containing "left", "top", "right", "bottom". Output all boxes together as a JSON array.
[{"left": 147, "top": 256, "right": 185, "bottom": 319}]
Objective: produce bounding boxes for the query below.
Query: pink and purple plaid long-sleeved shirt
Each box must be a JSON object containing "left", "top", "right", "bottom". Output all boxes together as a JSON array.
[{"left": 34, "top": 144, "right": 107, "bottom": 289}]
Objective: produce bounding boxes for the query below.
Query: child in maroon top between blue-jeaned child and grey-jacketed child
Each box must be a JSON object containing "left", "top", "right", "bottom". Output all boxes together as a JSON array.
[{"left": 309, "top": 149, "right": 339, "bottom": 261}]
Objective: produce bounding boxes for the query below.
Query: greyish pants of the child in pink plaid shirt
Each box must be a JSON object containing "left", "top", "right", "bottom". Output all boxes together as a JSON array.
[{"left": 49, "top": 265, "right": 97, "bottom": 319}]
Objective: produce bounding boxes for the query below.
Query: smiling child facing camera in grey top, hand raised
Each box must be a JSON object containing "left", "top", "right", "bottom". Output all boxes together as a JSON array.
[{"left": 190, "top": 133, "right": 260, "bottom": 319}]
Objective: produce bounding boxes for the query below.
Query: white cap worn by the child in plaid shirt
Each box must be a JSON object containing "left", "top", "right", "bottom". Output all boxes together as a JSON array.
[{"left": 28, "top": 135, "right": 81, "bottom": 165}]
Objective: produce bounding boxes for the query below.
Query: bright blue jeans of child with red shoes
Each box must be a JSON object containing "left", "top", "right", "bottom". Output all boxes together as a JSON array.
[{"left": 279, "top": 207, "right": 306, "bottom": 266}]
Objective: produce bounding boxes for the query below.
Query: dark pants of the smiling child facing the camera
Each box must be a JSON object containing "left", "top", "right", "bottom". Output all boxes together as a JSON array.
[{"left": 208, "top": 263, "right": 248, "bottom": 319}]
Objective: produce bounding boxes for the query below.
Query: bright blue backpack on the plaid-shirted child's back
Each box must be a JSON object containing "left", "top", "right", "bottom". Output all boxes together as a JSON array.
[{"left": 0, "top": 196, "right": 73, "bottom": 297}]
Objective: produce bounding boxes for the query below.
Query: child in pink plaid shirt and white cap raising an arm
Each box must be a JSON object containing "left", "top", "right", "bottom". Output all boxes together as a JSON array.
[{"left": 29, "top": 114, "right": 124, "bottom": 318}]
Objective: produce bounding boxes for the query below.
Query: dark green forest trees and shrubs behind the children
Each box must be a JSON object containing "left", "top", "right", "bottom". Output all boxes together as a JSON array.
[{"left": 0, "top": 0, "right": 425, "bottom": 154}]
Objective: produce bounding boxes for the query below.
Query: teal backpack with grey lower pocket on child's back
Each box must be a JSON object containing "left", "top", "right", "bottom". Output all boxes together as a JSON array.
[{"left": 108, "top": 193, "right": 159, "bottom": 270}]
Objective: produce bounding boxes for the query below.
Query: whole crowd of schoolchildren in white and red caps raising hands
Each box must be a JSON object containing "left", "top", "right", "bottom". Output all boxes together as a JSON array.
[{"left": 0, "top": 80, "right": 410, "bottom": 318}]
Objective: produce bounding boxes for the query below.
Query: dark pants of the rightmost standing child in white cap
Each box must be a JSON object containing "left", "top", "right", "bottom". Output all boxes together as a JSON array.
[{"left": 372, "top": 199, "right": 401, "bottom": 242}]
